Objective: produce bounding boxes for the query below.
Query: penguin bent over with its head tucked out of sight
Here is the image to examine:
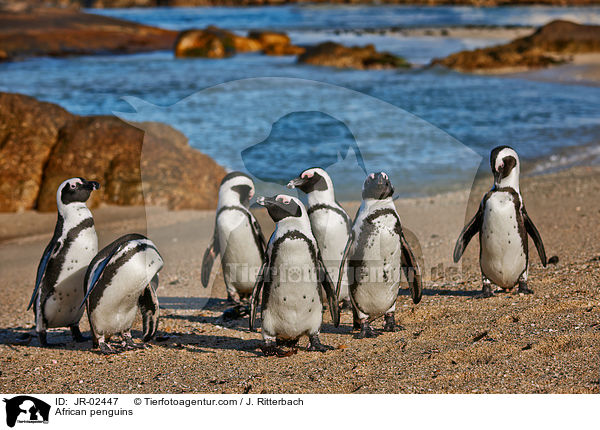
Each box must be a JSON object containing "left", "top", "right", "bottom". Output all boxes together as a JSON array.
[{"left": 81, "top": 233, "right": 164, "bottom": 354}]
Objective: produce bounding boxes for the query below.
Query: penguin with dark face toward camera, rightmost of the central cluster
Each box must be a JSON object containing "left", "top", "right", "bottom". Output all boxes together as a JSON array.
[{"left": 337, "top": 172, "right": 422, "bottom": 338}]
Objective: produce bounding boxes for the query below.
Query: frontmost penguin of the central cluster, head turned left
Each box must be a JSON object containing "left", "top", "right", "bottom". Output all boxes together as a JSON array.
[{"left": 250, "top": 194, "right": 339, "bottom": 355}]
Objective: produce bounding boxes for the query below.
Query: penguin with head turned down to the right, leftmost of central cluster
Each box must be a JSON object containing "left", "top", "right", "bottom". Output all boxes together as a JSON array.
[{"left": 201, "top": 172, "right": 265, "bottom": 312}]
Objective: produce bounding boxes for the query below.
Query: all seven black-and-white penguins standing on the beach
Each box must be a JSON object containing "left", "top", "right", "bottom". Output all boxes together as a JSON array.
[{"left": 29, "top": 146, "right": 546, "bottom": 356}]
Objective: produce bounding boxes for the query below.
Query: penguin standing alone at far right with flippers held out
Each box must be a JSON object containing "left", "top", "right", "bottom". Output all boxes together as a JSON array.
[{"left": 454, "top": 146, "right": 546, "bottom": 297}]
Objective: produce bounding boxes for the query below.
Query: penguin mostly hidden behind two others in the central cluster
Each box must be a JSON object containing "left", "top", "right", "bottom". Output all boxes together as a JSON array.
[{"left": 287, "top": 168, "right": 352, "bottom": 307}]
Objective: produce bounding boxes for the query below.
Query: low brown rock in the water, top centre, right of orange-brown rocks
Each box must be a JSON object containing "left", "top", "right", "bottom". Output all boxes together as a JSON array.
[{"left": 298, "top": 42, "right": 410, "bottom": 69}]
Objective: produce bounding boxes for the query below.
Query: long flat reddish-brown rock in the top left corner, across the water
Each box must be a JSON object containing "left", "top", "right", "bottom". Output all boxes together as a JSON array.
[{"left": 0, "top": 8, "right": 177, "bottom": 58}]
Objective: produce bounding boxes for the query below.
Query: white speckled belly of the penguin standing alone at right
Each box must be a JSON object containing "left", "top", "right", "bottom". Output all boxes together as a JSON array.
[{"left": 480, "top": 191, "right": 527, "bottom": 288}]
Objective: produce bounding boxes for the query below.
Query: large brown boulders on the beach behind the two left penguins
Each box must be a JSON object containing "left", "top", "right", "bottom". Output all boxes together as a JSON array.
[{"left": 0, "top": 93, "right": 226, "bottom": 211}]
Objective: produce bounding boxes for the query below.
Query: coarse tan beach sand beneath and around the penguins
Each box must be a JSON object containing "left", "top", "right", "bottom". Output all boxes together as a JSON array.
[{"left": 0, "top": 167, "right": 600, "bottom": 393}]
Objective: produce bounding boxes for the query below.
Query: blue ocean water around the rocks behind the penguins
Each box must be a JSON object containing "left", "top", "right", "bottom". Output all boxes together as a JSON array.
[{"left": 0, "top": 6, "right": 600, "bottom": 200}]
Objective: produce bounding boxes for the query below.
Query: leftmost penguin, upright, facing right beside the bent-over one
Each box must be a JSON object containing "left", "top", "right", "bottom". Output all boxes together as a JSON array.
[{"left": 27, "top": 178, "right": 100, "bottom": 346}]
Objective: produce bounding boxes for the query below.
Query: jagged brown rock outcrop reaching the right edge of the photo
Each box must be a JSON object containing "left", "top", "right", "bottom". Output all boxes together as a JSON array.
[{"left": 431, "top": 20, "right": 600, "bottom": 71}]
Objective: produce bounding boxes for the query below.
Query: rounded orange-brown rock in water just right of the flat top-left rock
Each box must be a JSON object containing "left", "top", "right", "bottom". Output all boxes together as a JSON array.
[{"left": 175, "top": 26, "right": 262, "bottom": 58}]
